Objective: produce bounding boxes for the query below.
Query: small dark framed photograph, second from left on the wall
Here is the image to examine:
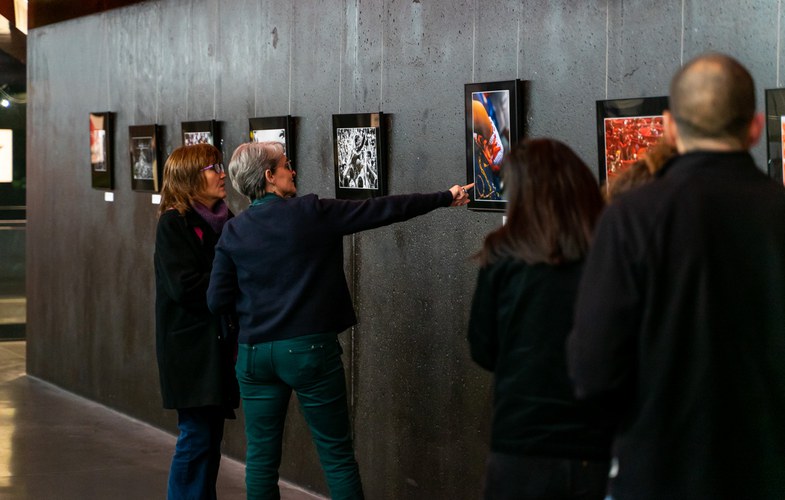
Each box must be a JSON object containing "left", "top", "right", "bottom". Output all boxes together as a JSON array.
[{"left": 128, "top": 125, "right": 164, "bottom": 193}]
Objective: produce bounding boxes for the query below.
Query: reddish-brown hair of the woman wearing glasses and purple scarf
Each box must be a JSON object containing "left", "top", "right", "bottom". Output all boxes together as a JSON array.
[{"left": 158, "top": 144, "right": 222, "bottom": 214}]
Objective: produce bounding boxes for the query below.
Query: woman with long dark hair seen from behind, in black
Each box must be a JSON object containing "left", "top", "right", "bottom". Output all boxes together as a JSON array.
[{"left": 468, "top": 139, "right": 611, "bottom": 499}]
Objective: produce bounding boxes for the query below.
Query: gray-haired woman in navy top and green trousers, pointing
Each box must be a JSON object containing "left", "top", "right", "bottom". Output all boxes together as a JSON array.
[{"left": 207, "top": 142, "right": 473, "bottom": 499}]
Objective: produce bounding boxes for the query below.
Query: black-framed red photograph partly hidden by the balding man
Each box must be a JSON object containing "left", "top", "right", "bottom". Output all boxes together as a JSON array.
[{"left": 597, "top": 96, "right": 668, "bottom": 184}]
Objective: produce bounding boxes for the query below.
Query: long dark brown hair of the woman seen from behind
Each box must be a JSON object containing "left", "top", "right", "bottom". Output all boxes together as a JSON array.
[{"left": 477, "top": 138, "right": 603, "bottom": 266}]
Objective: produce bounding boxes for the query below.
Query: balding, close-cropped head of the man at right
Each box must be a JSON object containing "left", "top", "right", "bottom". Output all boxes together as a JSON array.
[{"left": 665, "top": 54, "right": 763, "bottom": 152}]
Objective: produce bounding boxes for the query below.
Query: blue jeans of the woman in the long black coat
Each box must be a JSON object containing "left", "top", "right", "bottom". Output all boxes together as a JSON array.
[{"left": 166, "top": 406, "right": 225, "bottom": 500}]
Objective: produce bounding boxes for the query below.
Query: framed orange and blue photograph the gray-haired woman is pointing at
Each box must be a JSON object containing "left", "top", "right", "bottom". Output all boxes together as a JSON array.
[{"left": 464, "top": 80, "right": 525, "bottom": 211}]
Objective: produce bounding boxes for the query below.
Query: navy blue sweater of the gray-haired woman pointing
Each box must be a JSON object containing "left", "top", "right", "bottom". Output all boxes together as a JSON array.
[{"left": 207, "top": 191, "right": 453, "bottom": 344}]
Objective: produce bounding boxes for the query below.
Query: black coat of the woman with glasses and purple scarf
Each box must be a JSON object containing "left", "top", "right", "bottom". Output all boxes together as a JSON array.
[{"left": 154, "top": 210, "right": 239, "bottom": 408}]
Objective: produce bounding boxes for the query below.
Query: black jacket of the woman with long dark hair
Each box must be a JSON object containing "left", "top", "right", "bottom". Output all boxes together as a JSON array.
[{"left": 469, "top": 259, "right": 611, "bottom": 460}]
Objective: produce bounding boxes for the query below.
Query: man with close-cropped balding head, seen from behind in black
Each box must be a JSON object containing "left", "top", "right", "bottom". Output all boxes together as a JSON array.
[{"left": 568, "top": 54, "right": 785, "bottom": 500}]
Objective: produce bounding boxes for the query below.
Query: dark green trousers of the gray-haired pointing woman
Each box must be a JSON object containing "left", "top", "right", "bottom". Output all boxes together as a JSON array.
[{"left": 236, "top": 334, "right": 363, "bottom": 500}]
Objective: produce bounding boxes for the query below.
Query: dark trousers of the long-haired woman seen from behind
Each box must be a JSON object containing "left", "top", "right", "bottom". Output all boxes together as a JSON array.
[{"left": 484, "top": 452, "right": 610, "bottom": 500}]
